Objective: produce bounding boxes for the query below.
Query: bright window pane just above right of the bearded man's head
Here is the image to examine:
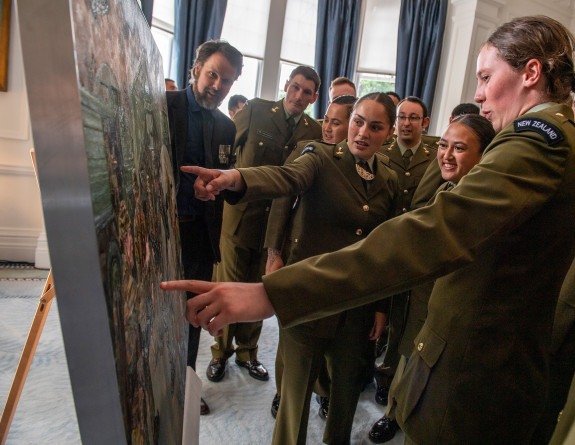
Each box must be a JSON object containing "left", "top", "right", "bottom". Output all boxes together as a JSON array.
[{"left": 221, "top": 0, "right": 270, "bottom": 58}]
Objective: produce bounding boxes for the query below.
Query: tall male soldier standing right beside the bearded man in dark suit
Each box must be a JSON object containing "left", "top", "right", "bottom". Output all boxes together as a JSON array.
[{"left": 207, "top": 67, "right": 321, "bottom": 381}]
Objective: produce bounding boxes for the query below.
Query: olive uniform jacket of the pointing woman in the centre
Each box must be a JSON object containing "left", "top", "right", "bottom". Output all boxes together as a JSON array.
[{"left": 230, "top": 141, "right": 399, "bottom": 338}]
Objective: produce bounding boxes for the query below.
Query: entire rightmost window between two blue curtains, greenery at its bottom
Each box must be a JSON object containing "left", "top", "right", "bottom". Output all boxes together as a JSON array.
[{"left": 356, "top": 0, "right": 401, "bottom": 96}]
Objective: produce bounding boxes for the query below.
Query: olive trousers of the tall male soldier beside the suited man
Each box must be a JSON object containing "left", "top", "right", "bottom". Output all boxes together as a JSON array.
[{"left": 212, "top": 232, "right": 267, "bottom": 361}]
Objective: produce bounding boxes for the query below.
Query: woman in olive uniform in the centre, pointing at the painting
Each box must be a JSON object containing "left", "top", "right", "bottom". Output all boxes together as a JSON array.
[{"left": 184, "top": 93, "right": 399, "bottom": 445}]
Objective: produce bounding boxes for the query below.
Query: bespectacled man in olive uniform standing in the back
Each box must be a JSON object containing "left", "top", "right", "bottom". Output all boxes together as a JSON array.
[{"left": 375, "top": 96, "right": 437, "bottom": 405}]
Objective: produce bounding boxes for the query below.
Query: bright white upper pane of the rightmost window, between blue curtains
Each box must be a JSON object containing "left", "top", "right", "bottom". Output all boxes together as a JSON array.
[{"left": 357, "top": 0, "right": 401, "bottom": 74}]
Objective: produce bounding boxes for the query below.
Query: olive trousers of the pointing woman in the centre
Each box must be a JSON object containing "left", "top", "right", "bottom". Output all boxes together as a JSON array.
[{"left": 272, "top": 309, "right": 373, "bottom": 445}]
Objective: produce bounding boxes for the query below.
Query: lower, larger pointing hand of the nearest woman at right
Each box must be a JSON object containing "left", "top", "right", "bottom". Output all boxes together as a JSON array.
[{"left": 160, "top": 280, "right": 274, "bottom": 336}]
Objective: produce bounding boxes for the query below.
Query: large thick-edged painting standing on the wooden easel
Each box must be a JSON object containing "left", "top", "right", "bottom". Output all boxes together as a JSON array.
[{"left": 18, "top": 0, "right": 187, "bottom": 444}]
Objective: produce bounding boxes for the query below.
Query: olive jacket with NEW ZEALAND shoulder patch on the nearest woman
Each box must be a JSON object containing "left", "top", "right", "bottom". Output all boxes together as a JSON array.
[{"left": 263, "top": 105, "right": 575, "bottom": 444}]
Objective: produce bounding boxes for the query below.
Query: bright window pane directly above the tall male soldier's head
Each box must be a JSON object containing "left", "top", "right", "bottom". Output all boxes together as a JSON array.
[{"left": 281, "top": 0, "right": 317, "bottom": 66}]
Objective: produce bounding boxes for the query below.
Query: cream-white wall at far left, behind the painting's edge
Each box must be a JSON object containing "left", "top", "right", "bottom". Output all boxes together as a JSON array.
[{"left": 0, "top": 4, "right": 43, "bottom": 262}]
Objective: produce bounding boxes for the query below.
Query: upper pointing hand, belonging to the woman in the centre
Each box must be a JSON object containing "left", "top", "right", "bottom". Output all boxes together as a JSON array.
[{"left": 180, "top": 166, "right": 246, "bottom": 201}]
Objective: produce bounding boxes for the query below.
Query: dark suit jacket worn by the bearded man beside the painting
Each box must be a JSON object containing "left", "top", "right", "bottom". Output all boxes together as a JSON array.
[{"left": 166, "top": 86, "right": 236, "bottom": 261}]
